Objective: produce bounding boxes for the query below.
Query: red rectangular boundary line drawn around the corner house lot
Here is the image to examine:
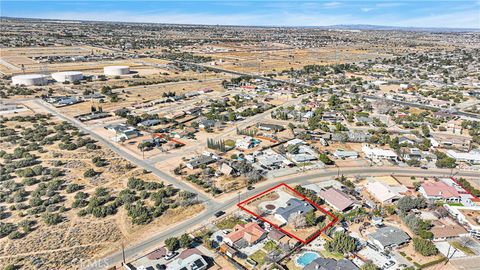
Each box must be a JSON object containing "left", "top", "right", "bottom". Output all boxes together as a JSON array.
[{"left": 237, "top": 183, "right": 338, "bottom": 244}]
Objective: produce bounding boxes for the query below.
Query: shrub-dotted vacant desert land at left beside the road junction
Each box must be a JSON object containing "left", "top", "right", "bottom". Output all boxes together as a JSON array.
[{"left": 0, "top": 109, "right": 203, "bottom": 269}]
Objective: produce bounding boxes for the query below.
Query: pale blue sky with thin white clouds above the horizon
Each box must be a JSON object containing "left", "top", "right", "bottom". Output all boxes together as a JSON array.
[{"left": 0, "top": 0, "right": 480, "bottom": 28}]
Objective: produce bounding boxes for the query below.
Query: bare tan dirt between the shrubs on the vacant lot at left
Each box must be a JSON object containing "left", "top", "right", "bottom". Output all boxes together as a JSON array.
[{"left": 0, "top": 109, "right": 204, "bottom": 269}]
